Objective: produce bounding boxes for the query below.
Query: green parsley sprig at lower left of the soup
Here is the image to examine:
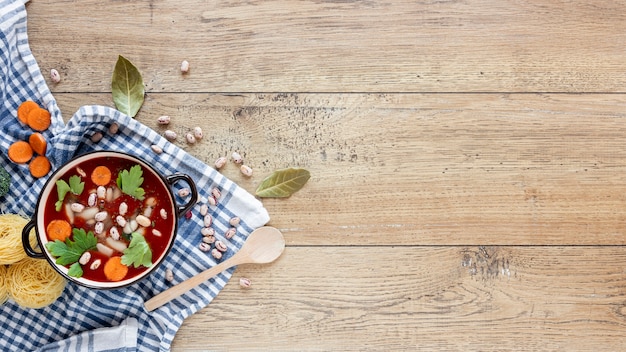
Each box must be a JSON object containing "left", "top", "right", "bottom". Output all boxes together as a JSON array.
[{"left": 46, "top": 228, "right": 98, "bottom": 277}]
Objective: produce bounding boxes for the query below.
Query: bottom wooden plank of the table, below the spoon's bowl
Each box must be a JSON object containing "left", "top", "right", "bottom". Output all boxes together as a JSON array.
[{"left": 173, "top": 246, "right": 626, "bottom": 351}]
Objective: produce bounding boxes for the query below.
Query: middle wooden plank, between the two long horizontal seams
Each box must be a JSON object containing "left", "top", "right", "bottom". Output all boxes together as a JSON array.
[{"left": 51, "top": 93, "right": 626, "bottom": 245}]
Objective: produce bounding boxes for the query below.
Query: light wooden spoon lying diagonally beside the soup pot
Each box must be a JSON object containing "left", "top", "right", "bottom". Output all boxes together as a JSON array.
[{"left": 144, "top": 226, "right": 285, "bottom": 312}]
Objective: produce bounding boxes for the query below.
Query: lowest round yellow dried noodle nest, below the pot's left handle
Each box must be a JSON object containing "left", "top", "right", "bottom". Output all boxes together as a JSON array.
[{"left": 5, "top": 258, "right": 66, "bottom": 309}]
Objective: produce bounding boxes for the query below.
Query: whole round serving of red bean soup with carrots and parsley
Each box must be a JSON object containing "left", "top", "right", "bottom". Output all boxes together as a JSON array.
[{"left": 44, "top": 156, "right": 177, "bottom": 282}]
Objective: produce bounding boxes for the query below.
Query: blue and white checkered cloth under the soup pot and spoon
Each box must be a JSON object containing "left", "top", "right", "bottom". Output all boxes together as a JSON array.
[{"left": 0, "top": 0, "right": 269, "bottom": 351}]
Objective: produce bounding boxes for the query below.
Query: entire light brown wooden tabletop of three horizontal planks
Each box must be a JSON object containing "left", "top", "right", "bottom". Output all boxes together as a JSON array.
[{"left": 22, "top": 0, "right": 626, "bottom": 351}]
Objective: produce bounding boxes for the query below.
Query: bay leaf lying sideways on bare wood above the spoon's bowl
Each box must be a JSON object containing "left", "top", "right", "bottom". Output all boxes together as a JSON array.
[{"left": 256, "top": 168, "right": 311, "bottom": 198}]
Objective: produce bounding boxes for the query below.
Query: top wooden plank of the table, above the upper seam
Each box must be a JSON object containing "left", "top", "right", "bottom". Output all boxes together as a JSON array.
[{"left": 28, "top": 0, "right": 626, "bottom": 92}]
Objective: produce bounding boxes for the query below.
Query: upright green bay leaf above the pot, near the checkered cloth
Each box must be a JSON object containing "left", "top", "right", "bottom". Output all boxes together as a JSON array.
[{"left": 111, "top": 55, "right": 146, "bottom": 117}]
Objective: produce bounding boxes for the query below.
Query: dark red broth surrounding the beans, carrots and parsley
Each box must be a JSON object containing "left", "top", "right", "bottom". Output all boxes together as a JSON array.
[{"left": 44, "top": 157, "right": 176, "bottom": 282}]
